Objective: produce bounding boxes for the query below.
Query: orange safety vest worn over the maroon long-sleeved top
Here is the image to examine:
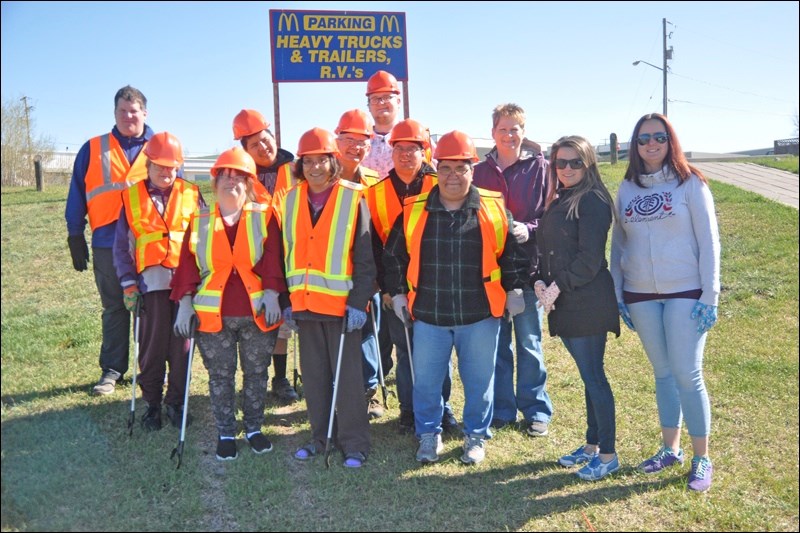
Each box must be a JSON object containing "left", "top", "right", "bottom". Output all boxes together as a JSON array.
[{"left": 189, "top": 202, "right": 280, "bottom": 333}]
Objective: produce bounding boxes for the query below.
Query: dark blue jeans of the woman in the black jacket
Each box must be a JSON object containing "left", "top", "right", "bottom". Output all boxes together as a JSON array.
[{"left": 561, "top": 333, "right": 617, "bottom": 453}]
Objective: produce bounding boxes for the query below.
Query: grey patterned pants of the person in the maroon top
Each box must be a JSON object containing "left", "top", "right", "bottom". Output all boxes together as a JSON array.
[{"left": 197, "top": 316, "right": 278, "bottom": 437}]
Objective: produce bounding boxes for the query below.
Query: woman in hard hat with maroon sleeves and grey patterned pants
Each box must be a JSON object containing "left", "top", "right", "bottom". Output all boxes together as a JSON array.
[{"left": 171, "top": 147, "right": 286, "bottom": 461}]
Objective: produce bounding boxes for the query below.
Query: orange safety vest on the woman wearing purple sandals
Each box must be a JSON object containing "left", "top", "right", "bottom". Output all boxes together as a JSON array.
[{"left": 282, "top": 179, "right": 364, "bottom": 316}]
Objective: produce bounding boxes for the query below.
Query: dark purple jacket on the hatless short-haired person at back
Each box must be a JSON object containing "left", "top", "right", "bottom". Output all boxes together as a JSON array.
[{"left": 472, "top": 146, "right": 549, "bottom": 275}]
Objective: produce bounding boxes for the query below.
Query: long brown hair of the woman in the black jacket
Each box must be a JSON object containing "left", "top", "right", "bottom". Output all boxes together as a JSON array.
[{"left": 544, "top": 135, "right": 614, "bottom": 219}]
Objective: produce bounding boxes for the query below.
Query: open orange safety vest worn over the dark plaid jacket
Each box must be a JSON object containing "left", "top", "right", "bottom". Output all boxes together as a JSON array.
[{"left": 403, "top": 189, "right": 508, "bottom": 318}]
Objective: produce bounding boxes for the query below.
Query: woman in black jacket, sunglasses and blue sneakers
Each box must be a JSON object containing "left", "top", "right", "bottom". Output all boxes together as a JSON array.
[{"left": 534, "top": 136, "right": 619, "bottom": 480}]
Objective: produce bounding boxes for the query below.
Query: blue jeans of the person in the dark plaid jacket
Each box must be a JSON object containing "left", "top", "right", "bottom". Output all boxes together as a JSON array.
[{"left": 413, "top": 317, "right": 500, "bottom": 438}]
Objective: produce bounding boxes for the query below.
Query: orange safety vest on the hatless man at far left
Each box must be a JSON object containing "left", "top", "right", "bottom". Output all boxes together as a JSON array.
[{"left": 84, "top": 133, "right": 147, "bottom": 231}]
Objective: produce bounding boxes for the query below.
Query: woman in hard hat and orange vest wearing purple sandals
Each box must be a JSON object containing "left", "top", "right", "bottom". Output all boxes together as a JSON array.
[{"left": 281, "top": 128, "right": 375, "bottom": 468}]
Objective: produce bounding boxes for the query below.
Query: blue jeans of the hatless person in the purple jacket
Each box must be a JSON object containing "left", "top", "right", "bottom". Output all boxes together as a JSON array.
[{"left": 494, "top": 287, "right": 553, "bottom": 423}]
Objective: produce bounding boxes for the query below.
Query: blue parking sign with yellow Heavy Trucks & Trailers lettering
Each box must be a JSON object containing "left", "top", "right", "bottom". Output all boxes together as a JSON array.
[{"left": 269, "top": 9, "right": 408, "bottom": 83}]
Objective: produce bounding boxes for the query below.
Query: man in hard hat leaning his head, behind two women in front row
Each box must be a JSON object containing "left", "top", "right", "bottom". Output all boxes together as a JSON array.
[{"left": 233, "top": 109, "right": 299, "bottom": 403}]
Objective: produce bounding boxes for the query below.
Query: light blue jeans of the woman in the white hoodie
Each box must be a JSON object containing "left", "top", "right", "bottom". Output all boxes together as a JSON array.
[{"left": 628, "top": 298, "right": 711, "bottom": 437}]
